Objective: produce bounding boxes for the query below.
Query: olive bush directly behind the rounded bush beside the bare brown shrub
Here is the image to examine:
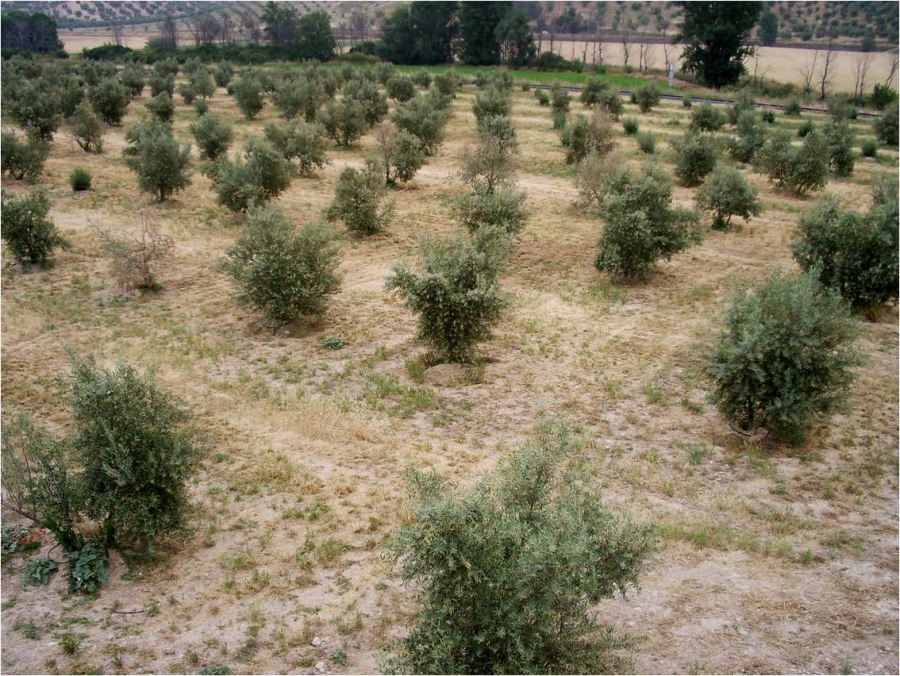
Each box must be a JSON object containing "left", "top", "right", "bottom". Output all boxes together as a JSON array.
[{"left": 213, "top": 140, "right": 294, "bottom": 212}]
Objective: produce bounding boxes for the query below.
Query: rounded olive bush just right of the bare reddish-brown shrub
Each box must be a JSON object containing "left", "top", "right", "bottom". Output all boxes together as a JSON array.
[{"left": 221, "top": 205, "right": 341, "bottom": 329}]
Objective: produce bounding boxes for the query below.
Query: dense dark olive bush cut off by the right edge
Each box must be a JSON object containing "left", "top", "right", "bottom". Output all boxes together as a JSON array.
[{"left": 791, "top": 191, "right": 900, "bottom": 309}]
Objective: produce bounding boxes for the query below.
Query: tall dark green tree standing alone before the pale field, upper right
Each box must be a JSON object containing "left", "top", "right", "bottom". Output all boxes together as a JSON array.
[{"left": 672, "top": 2, "right": 764, "bottom": 89}]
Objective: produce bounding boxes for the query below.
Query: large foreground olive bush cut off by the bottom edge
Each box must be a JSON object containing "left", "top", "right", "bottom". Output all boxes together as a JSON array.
[{"left": 387, "top": 423, "right": 656, "bottom": 674}]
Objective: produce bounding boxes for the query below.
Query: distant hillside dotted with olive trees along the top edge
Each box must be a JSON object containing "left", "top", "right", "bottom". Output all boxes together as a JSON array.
[{"left": 0, "top": 0, "right": 900, "bottom": 48}]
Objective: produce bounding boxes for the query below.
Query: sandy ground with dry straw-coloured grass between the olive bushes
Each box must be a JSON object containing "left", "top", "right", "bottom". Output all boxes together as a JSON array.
[{"left": 2, "top": 70, "right": 900, "bottom": 674}]
